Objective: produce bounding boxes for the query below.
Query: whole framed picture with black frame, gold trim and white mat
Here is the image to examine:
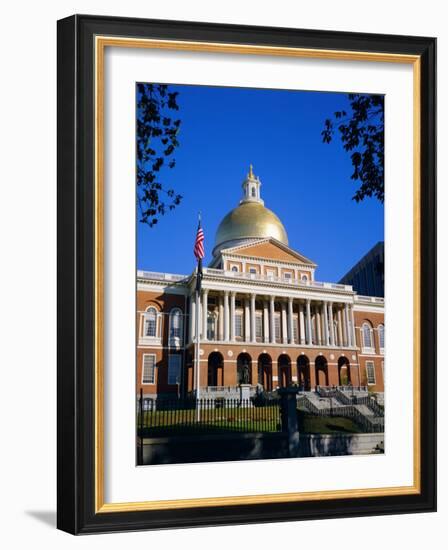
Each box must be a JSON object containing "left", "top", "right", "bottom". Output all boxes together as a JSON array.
[{"left": 58, "top": 15, "right": 436, "bottom": 534}]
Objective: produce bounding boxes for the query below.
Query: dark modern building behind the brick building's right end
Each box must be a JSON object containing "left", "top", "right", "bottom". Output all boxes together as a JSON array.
[{"left": 339, "top": 241, "right": 384, "bottom": 297}]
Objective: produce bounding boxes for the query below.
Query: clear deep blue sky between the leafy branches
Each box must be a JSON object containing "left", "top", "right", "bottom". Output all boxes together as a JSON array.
[{"left": 137, "top": 85, "right": 384, "bottom": 281}]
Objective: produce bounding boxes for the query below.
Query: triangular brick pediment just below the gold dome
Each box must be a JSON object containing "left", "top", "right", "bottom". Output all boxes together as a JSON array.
[{"left": 221, "top": 237, "right": 316, "bottom": 267}]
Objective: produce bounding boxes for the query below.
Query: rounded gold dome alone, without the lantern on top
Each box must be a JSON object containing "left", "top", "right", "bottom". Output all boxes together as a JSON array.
[{"left": 215, "top": 201, "right": 288, "bottom": 251}]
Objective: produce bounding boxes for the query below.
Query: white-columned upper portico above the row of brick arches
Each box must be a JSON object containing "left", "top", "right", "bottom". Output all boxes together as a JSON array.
[{"left": 189, "top": 269, "right": 355, "bottom": 348}]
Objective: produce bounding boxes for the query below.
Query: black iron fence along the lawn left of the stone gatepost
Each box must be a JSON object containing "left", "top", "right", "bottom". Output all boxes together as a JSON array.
[{"left": 137, "top": 397, "right": 281, "bottom": 437}]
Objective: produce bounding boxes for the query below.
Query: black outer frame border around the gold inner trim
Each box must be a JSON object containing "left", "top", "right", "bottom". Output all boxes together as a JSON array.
[{"left": 57, "top": 15, "right": 436, "bottom": 534}]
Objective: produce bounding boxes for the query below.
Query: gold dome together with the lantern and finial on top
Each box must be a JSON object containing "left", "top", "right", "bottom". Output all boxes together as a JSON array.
[{"left": 213, "top": 165, "right": 288, "bottom": 257}]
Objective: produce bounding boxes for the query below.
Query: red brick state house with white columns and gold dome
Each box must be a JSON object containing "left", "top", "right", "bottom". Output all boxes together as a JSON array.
[{"left": 137, "top": 168, "right": 384, "bottom": 397}]
